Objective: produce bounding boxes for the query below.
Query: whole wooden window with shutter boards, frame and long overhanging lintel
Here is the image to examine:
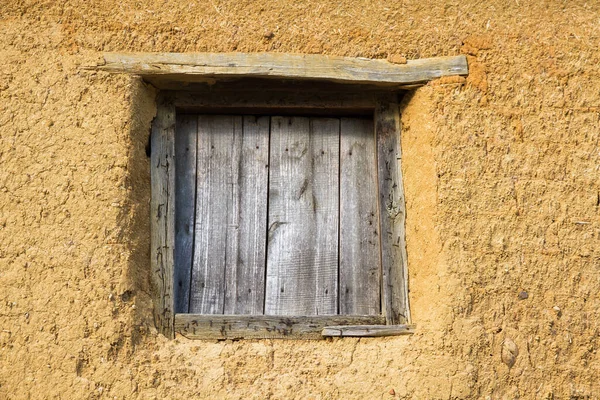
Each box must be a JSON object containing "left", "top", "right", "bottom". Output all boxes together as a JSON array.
[{"left": 97, "top": 49, "right": 468, "bottom": 339}]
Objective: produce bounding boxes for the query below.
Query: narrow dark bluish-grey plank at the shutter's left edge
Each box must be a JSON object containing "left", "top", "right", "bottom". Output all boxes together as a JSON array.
[{"left": 174, "top": 115, "right": 198, "bottom": 313}]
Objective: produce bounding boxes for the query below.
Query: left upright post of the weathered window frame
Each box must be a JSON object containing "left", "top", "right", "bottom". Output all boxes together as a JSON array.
[{"left": 150, "top": 96, "right": 175, "bottom": 337}]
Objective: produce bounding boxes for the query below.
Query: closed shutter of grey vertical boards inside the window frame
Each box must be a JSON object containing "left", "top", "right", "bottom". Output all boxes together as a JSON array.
[{"left": 175, "top": 114, "right": 381, "bottom": 316}]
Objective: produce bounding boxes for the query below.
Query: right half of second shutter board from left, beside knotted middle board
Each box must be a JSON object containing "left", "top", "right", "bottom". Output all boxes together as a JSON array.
[{"left": 224, "top": 116, "right": 270, "bottom": 314}]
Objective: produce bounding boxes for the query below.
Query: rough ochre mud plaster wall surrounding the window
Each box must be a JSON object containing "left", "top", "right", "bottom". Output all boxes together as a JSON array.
[{"left": 0, "top": 0, "right": 600, "bottom": 399}]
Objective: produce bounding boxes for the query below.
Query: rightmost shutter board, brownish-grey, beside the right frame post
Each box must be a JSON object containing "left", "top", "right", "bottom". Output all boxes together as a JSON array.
[{"left": 340, "top": 118, "right": 381, "bottom": 315}]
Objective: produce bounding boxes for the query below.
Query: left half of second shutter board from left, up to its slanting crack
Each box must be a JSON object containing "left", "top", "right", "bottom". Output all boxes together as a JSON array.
[{"left": 190, "top": 115, "right": 242, "bottom": 314}]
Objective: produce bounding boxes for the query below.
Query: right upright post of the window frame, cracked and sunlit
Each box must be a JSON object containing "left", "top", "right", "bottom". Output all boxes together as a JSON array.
[{"left": 375, "top": 98, "right": 410, "bottom": 325}]
